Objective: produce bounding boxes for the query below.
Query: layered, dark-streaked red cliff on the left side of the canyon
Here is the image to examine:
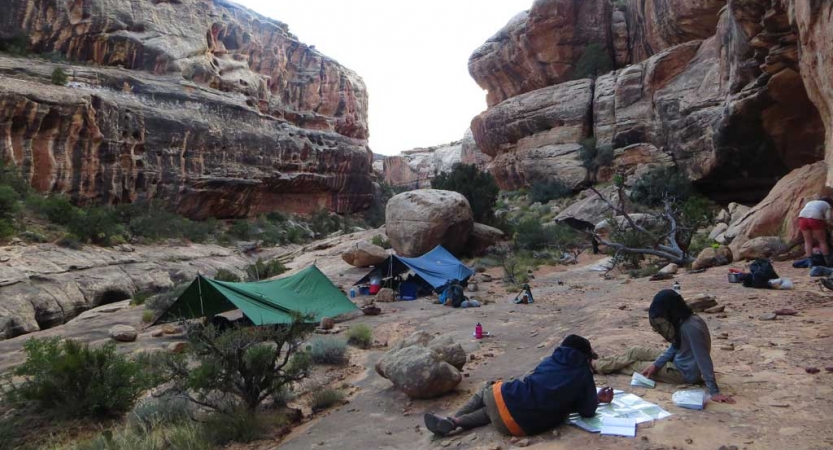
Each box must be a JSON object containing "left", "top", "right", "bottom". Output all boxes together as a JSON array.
[{"left": 0, "top": 0, "right": 373, "bottom": 218}]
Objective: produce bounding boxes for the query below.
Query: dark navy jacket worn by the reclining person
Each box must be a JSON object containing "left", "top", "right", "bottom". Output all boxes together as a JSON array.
[{"left": 501, "top": 347, "right": 599, "bottom": 435}]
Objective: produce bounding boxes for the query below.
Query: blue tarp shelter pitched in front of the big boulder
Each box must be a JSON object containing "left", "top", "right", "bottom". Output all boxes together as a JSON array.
[{"left": 356, "top": 245, "right": 474, "bottom": 290}]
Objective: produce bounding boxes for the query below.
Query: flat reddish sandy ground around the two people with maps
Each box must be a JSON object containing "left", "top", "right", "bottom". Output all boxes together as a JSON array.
[{"left": 0, "top": 252, "right": 833, "bottom": 450}]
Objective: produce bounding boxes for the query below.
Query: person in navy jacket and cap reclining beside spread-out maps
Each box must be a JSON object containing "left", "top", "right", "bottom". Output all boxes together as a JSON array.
[{"left": 424, "top": 334, "right": 613, "bottom": 436}]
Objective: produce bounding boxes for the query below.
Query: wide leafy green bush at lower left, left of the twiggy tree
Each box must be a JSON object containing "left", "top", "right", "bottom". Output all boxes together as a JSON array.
[{"left": 7, "top": 338, "right": 149, "bottom": 418}]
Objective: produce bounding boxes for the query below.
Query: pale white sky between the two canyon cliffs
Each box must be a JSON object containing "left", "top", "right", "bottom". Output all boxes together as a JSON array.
[{"left": 236, "top": 0, "right": 532, "bottom": 155}]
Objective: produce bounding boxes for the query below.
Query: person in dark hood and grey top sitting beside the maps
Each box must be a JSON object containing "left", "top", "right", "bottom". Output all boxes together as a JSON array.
[{"left": 593, "top": 289, "right": 735, "bottom": 403}]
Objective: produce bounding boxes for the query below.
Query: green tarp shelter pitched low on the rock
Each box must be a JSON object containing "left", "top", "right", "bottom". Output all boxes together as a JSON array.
[{"left": 154, "top": 265, "right": 359, "bottom": 325}]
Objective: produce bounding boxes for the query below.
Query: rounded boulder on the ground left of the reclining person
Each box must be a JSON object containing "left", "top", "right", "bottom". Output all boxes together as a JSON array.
[{"left": 376, "top": 331, "right": 466, "bottom": 398}]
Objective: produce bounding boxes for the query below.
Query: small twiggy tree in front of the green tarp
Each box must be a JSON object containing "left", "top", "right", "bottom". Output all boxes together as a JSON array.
[{"left": 167, "top": 317, "right": 311, "bottom": 415}]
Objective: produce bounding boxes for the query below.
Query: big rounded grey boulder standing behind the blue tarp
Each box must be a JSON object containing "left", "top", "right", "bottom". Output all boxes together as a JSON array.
[{"left": 385, "top": 189, "right": 474, "bottom": 257}]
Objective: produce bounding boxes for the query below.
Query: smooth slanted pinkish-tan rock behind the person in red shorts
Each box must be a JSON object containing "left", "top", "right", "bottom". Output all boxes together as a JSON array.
[{"left": 725, "top": 161, "right": 833, "bottom": 255}]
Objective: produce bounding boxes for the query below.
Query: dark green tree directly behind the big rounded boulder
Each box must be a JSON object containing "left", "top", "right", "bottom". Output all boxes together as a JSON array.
[{"left": 431, "top": 163, "right": 500, "bottom": 223}]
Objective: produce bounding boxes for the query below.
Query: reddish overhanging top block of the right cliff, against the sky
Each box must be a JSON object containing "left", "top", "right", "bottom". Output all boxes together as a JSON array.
[{"left": 469, "top": 0, "right": 612, "bottom": 107}]
